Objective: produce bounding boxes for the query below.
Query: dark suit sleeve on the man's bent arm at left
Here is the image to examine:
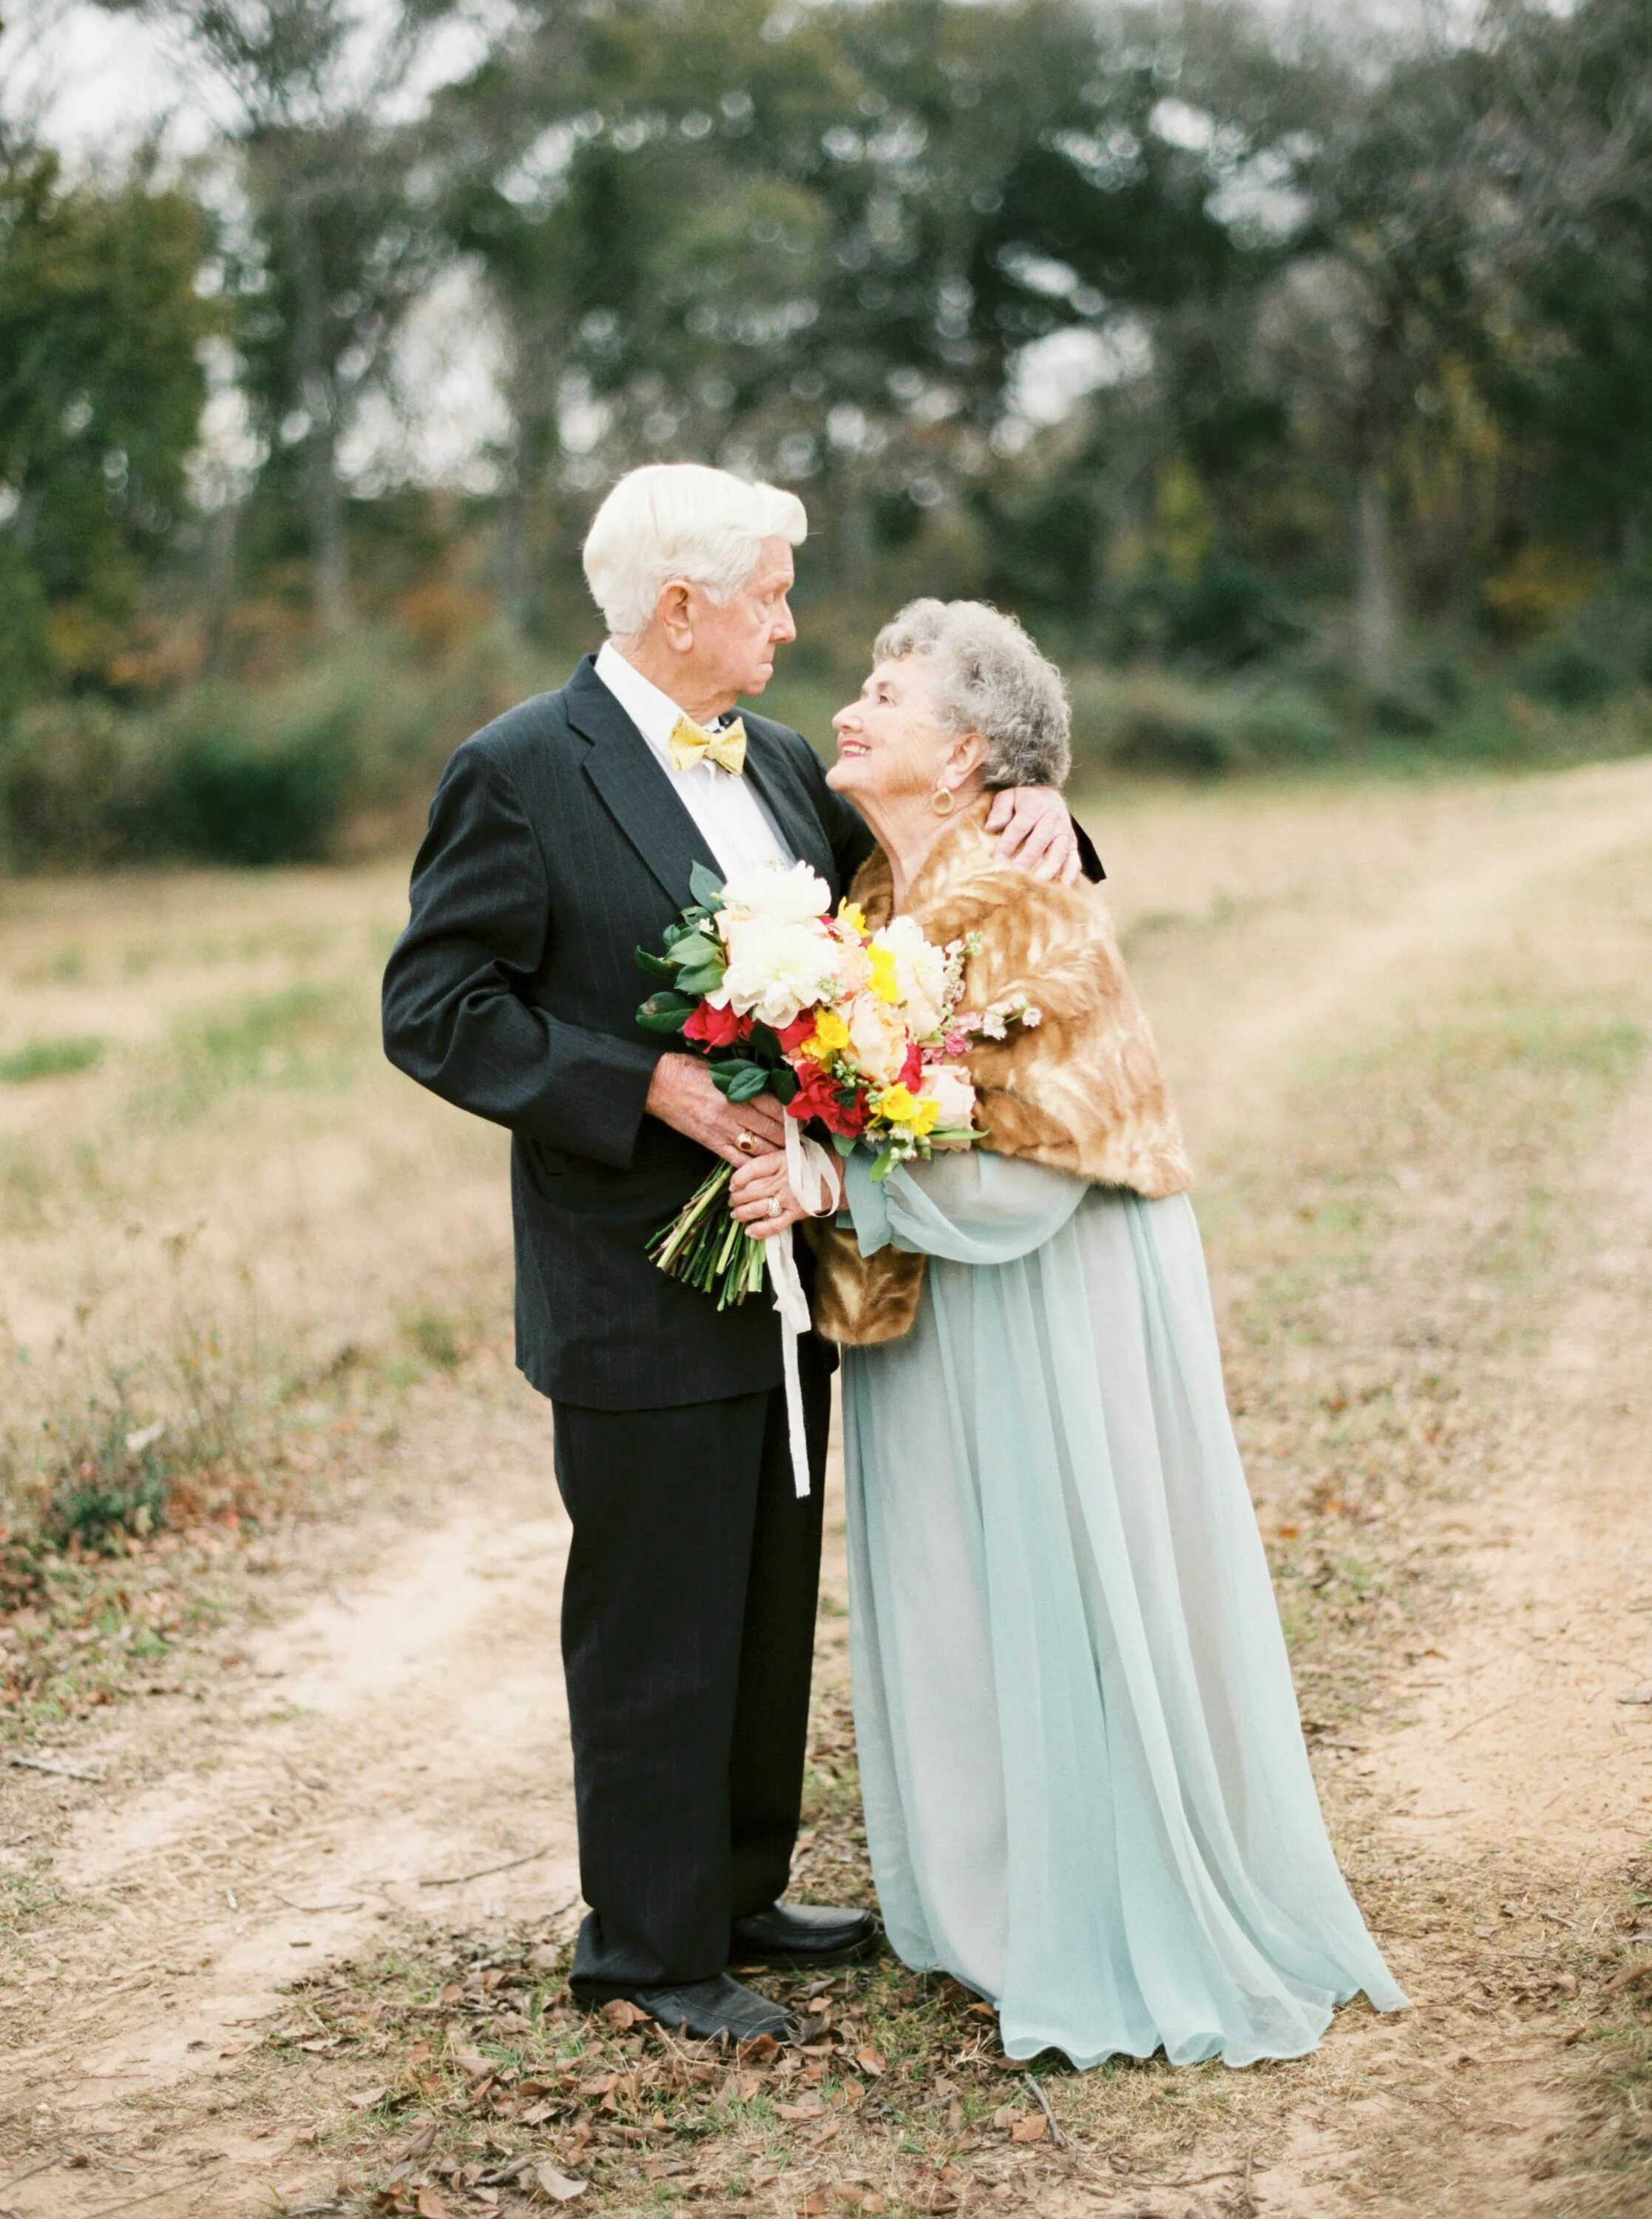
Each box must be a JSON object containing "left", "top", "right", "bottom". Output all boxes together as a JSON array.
[{"left": 384, "top": 748, "right": 661, "bottom": 1169}]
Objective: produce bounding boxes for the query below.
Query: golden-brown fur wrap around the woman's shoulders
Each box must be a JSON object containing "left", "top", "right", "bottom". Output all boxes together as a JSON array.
[{"left": 814, "top": 797, "right": 1193, "bottom": 1347}]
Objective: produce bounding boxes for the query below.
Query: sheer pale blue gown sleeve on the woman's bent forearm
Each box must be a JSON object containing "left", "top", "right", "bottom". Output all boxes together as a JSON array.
[{"left": 844, "top": 1147, "right": 1091, "bottom": 1265}]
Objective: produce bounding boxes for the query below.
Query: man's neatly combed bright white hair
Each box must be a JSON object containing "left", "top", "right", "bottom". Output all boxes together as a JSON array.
[{"left": 586, "top": 462, "right": 810, "bottom": 639}]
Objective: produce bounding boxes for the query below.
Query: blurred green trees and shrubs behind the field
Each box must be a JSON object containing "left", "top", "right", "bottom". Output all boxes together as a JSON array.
[{"left": 0, "top": 0, "right": 1652, "bottom": 861}]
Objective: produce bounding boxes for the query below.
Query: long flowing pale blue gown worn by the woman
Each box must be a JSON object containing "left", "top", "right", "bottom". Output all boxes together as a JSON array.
[{"left": 842, "top": 1152, "right": 1406, "bottom": 2066}]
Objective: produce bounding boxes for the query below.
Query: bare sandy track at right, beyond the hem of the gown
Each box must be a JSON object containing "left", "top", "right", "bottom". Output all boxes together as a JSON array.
[{"left": 1255, "top": 1061, "right": 1652, "bottom": 2219}]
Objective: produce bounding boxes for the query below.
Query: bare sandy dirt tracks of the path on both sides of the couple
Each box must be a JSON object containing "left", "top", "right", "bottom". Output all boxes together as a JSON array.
[{"left": 0, "top": 766, "right": 1652, "bottom": 2219}]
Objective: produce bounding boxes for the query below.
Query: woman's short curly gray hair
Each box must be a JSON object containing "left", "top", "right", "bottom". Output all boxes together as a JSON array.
[{"left": 871, "top": 599, "right": 1073, "bottom": 788}]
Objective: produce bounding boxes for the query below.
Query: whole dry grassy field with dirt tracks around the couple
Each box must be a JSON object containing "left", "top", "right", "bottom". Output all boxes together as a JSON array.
[{"left": 0, "top": 761, "right": 1652, "bottom": 2219}]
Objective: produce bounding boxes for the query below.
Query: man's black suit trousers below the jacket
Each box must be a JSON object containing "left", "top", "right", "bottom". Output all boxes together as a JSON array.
[{"left": 555, "top": 1338, "right": 831, "bottom": 1988}]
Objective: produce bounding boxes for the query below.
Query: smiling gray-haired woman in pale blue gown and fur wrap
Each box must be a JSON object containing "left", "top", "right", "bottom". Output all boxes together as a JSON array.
[{"left": 780, "top": 601, "right": 1404, "bottom": 2066}]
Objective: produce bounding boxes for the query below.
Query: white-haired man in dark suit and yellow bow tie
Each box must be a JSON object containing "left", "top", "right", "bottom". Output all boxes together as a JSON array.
[{"left": 384, "top": 464, "right": 1091, "bottom": 2039}]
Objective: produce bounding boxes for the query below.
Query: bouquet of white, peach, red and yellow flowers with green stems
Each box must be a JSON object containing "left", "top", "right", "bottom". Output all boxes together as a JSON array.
[{"left": 637, "top": 863, "right": 1037, "bottom": 1309}]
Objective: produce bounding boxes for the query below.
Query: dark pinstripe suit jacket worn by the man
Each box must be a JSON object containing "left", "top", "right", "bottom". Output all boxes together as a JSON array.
[{"left": 384, "top": 659, "right": 871, "bottom": 1409}]
